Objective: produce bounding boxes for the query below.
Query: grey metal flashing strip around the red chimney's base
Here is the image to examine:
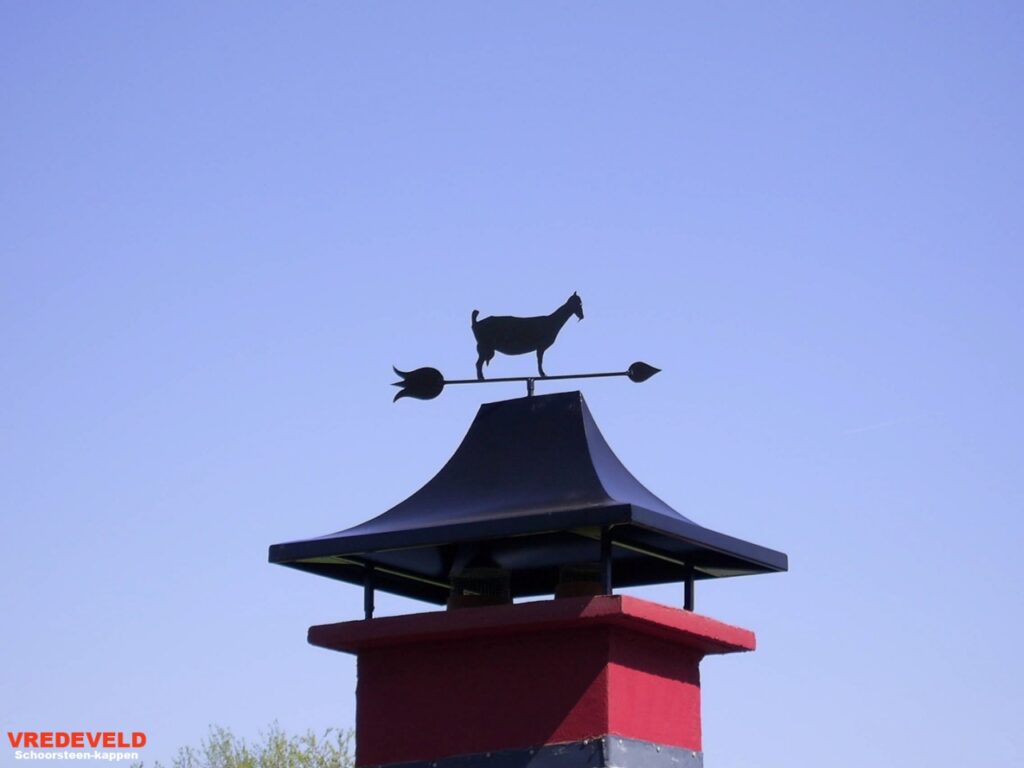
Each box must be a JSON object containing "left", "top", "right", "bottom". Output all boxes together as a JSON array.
[{"left": 367, "top": 736, "right": 703, "bottom": 768}]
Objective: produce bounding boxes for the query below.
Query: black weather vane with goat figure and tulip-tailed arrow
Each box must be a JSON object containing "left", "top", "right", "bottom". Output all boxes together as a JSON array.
[{"left": 392, "top": 293, "right": 660, "bottom": 401}]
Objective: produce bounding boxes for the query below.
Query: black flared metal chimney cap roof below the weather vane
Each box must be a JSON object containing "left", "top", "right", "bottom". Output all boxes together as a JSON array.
[{"left": 269, "top": 392, "right": 787, "bottom": 603}]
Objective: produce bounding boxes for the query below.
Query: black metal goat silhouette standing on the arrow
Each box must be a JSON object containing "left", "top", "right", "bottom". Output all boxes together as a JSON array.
[{"left": 473, "top": 293, "right": 583, "bottom": 381}]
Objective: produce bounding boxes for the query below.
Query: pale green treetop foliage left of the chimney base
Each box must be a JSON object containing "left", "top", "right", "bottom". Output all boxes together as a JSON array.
[{"left": 140, "top": 723, "right": 354, "bottom": 768}]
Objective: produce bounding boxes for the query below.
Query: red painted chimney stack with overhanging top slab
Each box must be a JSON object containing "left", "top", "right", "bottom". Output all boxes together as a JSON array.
[{"left": 309, "top": 596, "right": 755, "bottom": 766}]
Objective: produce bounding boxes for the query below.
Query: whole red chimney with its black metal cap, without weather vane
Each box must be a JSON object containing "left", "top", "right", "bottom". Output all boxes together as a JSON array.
[{"left": 270, "top": 392, "right": 787, "bottom": 768}]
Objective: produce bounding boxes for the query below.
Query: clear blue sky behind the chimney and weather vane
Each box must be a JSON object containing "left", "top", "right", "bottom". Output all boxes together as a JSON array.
[{"left": 0, "top": 1, "right": 1024, "bottom": 768}]
